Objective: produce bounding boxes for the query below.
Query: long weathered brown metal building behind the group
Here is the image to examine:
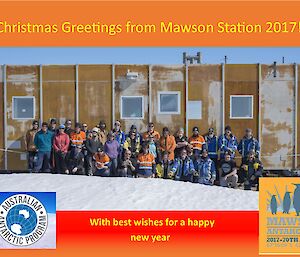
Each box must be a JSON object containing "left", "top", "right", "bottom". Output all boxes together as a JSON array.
[{"left": 0, "top": 64, "right": 300, "bottom": 170}]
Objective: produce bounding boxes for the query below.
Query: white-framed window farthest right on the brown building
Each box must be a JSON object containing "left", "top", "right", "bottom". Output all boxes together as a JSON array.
[{"left": 230, "top": 95, "right": 253, "bottom": 119}]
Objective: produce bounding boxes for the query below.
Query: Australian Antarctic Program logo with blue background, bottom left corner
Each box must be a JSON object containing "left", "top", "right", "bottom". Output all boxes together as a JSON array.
[{"left": 0, "top": 193, "right": 55, "bottom": 248}]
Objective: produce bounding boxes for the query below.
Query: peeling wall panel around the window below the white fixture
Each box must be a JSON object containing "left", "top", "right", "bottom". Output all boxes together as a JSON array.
[{"left": 113, "top": 65, "right": 149, "bottom": 131}]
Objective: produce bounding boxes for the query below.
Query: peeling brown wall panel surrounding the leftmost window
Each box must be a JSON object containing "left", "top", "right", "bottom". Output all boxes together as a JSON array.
[{"left": 6, "top": 66, "right": 39, "bottom": 170}]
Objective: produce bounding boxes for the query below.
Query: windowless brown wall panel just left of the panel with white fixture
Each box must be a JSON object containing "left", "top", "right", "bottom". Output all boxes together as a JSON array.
[{"left": 78, "top": 65, "right": 112, "bottom": 129}]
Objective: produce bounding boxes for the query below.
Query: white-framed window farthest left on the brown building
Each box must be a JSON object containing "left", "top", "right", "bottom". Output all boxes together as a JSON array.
[{"left": 12, "top": 96, "right": 35, "bottom": 120}]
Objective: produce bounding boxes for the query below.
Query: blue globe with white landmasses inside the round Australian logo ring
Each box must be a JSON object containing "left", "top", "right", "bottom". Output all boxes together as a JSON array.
[{"left": 6, "top": 204, "right": 37, "bottom": 236}]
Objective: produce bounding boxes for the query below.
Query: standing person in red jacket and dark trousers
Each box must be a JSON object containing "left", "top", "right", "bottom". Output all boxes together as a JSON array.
[{"left": 53, "top": 125, "right": 70, "bottom": 174}]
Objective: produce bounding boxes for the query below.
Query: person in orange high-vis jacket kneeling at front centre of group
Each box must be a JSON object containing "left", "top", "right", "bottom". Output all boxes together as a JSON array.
[{"left": 137, "top": 143, "right": 155, "bottom": 178}]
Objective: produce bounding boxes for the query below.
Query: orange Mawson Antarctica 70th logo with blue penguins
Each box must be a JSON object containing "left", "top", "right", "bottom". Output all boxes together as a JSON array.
[{"left": 259, "top": 178, "right": 300, "bottom": 254}]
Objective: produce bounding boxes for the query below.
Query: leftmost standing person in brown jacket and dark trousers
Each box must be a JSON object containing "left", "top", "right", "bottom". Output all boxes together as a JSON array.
[{"left": 24, "top": 120, "right": 39, "bottom": 171}]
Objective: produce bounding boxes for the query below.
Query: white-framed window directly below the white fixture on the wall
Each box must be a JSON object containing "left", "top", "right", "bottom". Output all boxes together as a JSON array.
[{"left": 121, "top": 96, "right": 144, "bottom": 119}]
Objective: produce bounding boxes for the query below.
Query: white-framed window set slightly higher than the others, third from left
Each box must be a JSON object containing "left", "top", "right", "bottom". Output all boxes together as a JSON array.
[{"left": 158, "top": 91, "right": 180, "bottom": 114}]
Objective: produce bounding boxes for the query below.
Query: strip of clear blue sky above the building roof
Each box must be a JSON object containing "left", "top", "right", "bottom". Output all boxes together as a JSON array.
[{"left": 0, "top": 47, "right": 300, "bottom": 65}]
